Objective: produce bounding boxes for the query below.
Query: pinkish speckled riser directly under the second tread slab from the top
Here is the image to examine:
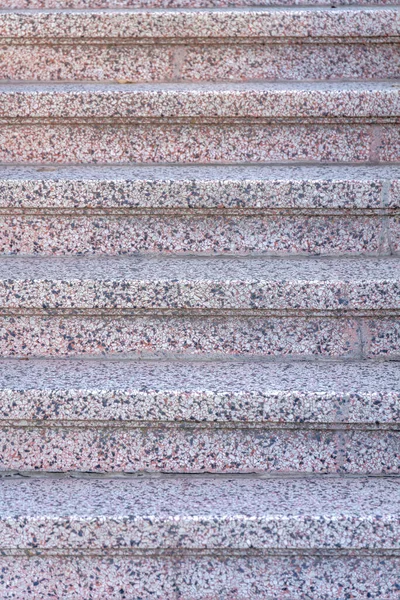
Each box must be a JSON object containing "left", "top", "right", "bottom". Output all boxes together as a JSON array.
[{"left": 0, "top": 124, "right": 400, "bottom": 164}]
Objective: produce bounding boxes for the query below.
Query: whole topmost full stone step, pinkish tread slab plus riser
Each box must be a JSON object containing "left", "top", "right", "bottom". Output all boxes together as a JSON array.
[{"left": 0, "top": 4, "right": 400, "bottom": 83}]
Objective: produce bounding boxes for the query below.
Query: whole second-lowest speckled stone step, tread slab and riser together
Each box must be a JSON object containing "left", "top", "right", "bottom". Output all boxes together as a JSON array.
[{"left": 0, "top": 359, "right": 400, "bottom": 474}]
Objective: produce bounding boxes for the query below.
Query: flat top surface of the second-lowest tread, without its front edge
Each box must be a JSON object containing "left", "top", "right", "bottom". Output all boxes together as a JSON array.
[{"left": 0, "top": 359, "right": 400, "bottom": 394}]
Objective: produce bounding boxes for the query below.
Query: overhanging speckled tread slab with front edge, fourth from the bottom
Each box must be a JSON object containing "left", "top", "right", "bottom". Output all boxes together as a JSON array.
[{"left": 0, "top": 165, "right": 400, "bottom": 215}]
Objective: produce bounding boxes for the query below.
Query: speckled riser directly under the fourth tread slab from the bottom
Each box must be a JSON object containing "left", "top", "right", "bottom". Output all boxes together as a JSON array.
[{"left": 0, "top": 214, "right": 392, "bottom": 256}]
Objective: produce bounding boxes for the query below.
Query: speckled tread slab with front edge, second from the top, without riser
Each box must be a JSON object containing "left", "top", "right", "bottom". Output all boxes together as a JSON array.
[{"left": 0, "top": 81, "right": 400, "bottom": 123}]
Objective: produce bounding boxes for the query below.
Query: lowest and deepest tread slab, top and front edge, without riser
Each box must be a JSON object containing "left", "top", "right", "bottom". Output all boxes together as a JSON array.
[{"left": 0, "top": 476, "right": 400, "bottom": 551}]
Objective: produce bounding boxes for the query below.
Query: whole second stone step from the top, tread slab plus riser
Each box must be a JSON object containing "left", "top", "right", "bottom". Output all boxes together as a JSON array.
[{"left": 0, "top": 82, "right": 400, "bottom": 164}]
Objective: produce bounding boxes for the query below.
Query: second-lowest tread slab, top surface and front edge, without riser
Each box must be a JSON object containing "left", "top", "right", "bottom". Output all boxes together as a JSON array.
[{"left": 0, "top": 360, "right": 400, "bottom": 429}]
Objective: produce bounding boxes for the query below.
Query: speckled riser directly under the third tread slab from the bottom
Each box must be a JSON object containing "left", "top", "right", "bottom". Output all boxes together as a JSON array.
[{"left": 0, "top": 316, "right": 400, "bottom": 359}]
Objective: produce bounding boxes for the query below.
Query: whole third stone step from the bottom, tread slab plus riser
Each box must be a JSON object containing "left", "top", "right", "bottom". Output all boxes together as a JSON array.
[{"left": 0, "top": 256, "right": 400, "bottom": 360}]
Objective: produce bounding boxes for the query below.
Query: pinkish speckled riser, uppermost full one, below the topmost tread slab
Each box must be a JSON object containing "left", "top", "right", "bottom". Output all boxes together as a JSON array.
[{"left": 0, "top": 43, "right": 400, "bottom": 83}]
